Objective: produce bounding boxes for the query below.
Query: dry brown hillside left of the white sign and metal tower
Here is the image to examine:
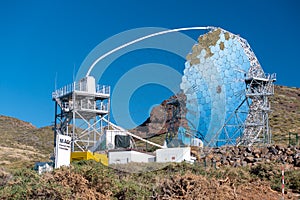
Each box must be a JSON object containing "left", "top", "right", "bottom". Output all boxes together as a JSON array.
[{"left": 0, "top": 116, "right": 53, "bottom": 168}]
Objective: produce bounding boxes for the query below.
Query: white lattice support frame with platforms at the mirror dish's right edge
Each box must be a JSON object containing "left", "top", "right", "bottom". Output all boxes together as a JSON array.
[{"left": 237, "top": 37, "right": 276, "bottom": 146}]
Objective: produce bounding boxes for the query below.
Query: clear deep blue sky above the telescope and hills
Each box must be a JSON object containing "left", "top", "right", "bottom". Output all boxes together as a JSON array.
[{"left": 0, "top": 0, "right": 300, "bottom": 127}]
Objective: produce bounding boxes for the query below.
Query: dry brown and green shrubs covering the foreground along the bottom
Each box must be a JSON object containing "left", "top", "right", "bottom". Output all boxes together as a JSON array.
[{"left": 0, "top": 161, "right": 297, "bottom": 200}]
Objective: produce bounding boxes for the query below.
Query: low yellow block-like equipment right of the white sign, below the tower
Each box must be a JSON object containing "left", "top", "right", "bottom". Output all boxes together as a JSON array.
[{"left": 71, "top": 151, "right": 108, "bottom": 166}]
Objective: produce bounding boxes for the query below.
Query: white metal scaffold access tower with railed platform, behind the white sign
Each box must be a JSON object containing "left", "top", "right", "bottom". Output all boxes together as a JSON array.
[{"left": 52, "top": 76, "right": 110, "bottom": 152}]
